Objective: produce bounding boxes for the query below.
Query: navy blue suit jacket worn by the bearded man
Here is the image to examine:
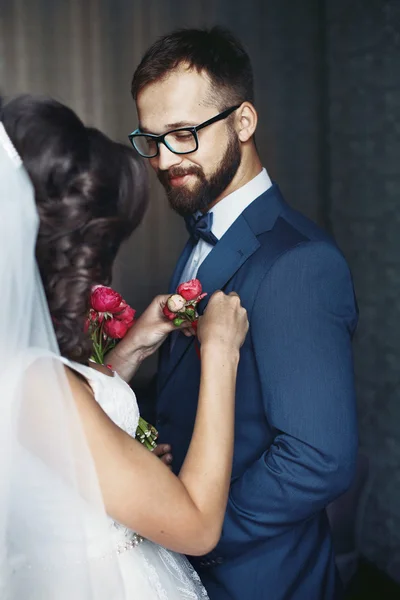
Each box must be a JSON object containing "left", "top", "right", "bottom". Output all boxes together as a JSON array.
[{"left": 157, "top": 185, "right": 357, "bottom": 600}]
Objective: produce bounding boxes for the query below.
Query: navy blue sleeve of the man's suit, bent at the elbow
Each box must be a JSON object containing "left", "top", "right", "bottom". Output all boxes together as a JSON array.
[{"left": 217, "top": 242, "right": 357, "bottom": 557}]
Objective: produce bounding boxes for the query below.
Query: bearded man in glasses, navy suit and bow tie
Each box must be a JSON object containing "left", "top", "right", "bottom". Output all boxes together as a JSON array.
[{"left": 121, "top": 28, "right": 357, "bottom": 600}]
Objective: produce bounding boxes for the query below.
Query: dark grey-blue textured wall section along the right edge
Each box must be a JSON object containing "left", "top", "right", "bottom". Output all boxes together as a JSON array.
[{"left": 326, "top": 0, "right": 400, "bottom": 581}]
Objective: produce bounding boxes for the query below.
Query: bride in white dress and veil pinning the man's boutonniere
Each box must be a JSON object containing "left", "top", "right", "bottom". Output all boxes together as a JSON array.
[{"left": 0, "top": 96, "right": 248, "bottom": 600}]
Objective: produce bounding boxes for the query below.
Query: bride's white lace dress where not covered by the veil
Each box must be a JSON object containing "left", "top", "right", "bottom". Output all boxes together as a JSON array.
[{"left": 64, "top": 361, "right": 208, "bottom": 600}]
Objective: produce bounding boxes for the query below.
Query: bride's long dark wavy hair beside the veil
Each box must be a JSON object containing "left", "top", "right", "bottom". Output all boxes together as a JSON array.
[{"left": 1, "top": 95, "right": 148, "bottom": 363}]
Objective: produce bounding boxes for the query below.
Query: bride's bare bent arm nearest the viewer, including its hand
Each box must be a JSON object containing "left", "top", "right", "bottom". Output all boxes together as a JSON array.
[{"left": 68, "top": 292, "right": 248, "bottom": 555}]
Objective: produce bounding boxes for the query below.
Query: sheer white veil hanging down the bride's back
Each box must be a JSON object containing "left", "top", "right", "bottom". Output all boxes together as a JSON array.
[{"left": 0, "top": 123, "right": 124, "bottom": 600}]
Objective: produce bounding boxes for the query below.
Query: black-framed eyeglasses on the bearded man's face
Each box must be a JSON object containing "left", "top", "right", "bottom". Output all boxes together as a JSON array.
[{"left": 128, "top": 104, "right": 241, "bottom": 158}]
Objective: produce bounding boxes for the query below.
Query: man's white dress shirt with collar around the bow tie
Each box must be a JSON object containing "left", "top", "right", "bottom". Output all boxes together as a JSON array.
[{"left": 180, "top": 169, "right": 272, "bottom": 283}]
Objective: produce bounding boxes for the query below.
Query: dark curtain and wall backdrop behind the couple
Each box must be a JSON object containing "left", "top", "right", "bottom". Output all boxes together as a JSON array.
[{"left": 0, "top": 0, "right": 400, "bottom": 582}]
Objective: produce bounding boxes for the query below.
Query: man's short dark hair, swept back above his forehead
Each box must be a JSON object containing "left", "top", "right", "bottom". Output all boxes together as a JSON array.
[{"left": 131, "top": 27, "right": 254, "bottom": 110}]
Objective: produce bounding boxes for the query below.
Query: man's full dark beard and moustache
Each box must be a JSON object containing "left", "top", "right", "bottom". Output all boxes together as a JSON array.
[{"left": 157, "top": 134, "right": 241, "bottom": 217}]
